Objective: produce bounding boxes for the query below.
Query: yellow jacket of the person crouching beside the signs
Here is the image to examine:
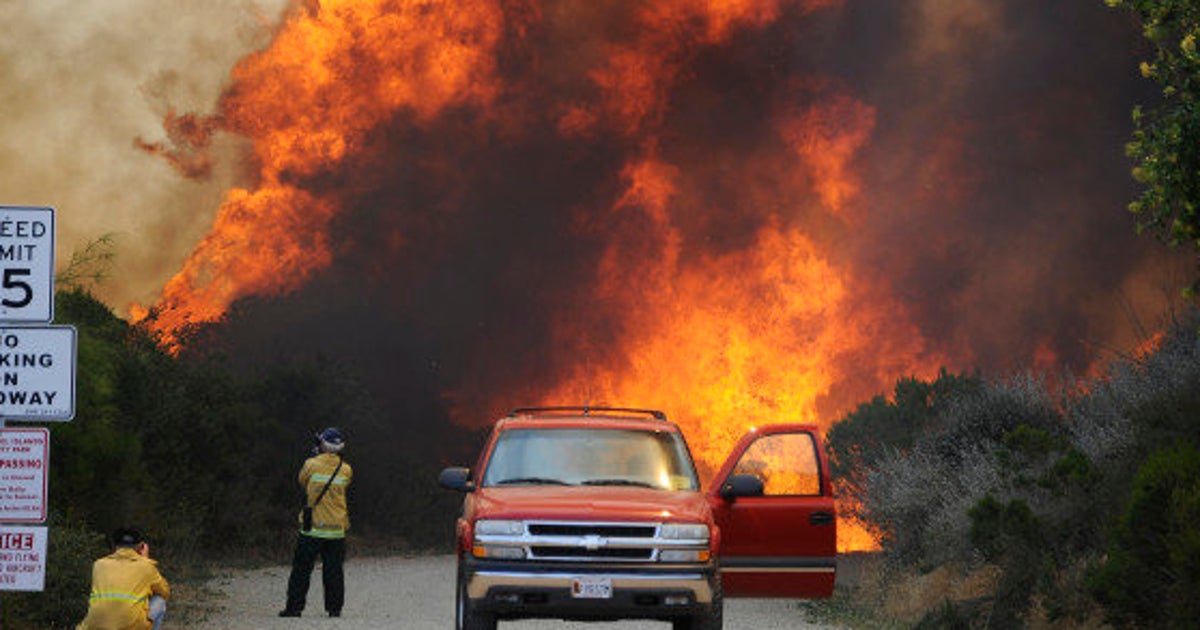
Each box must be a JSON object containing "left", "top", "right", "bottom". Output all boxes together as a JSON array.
[{"left": 78, "top": 547, "right": 170, "bottom": 630}]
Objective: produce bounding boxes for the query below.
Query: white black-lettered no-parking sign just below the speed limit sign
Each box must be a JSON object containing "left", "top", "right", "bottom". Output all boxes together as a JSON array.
[{"left": 0, "top": 326, "right": 76, "bottom": 420}]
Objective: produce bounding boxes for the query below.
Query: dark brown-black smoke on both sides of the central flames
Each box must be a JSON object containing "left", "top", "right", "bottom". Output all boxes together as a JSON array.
[{"left": 206, "top": 0, "right": 1189, "bottom": 422}]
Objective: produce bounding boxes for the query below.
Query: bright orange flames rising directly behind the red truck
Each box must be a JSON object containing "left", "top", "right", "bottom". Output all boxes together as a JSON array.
[{"left": 545, "top": 2, "right": 938, "bottom": 551}]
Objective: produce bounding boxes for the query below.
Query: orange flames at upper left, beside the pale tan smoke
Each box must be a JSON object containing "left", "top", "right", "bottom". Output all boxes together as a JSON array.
[{"left": 141, "top": 0, "right": 504, "bottom": 343}]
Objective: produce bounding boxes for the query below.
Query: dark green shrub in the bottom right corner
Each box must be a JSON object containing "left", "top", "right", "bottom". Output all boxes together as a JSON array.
[{"left": 1090, "top": 444, "right": 1200, "bottom": 628}]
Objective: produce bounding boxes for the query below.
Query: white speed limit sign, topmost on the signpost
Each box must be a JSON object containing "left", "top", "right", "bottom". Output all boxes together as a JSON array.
[{"left": 0, "top": 205, "right": 54, "bottom": 323}]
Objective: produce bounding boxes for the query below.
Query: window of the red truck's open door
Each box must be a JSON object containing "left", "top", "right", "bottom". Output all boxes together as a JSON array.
[{"left": 733, "top": 433, "right": 821, "bottom": 496}]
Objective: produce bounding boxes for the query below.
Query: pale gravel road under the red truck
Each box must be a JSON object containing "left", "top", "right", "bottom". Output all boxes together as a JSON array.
[{"left": 189, "top": 556, "right": 844, "bottom": 630}]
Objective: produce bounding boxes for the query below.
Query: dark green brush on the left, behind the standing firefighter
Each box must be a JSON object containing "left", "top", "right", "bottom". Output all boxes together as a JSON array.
[{"left": 0, "top": 289, "right": 468, "bottom": 628}]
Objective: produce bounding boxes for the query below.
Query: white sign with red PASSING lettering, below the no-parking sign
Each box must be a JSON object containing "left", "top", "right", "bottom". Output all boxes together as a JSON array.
[{"left": 0, "top": 427, "right": 50, "bottom": 523}]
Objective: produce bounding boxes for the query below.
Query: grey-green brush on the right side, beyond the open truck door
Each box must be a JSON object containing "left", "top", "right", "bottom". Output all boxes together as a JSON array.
[{"left": 829, "top": 316, "right": 1200, "bottom": 628}]
